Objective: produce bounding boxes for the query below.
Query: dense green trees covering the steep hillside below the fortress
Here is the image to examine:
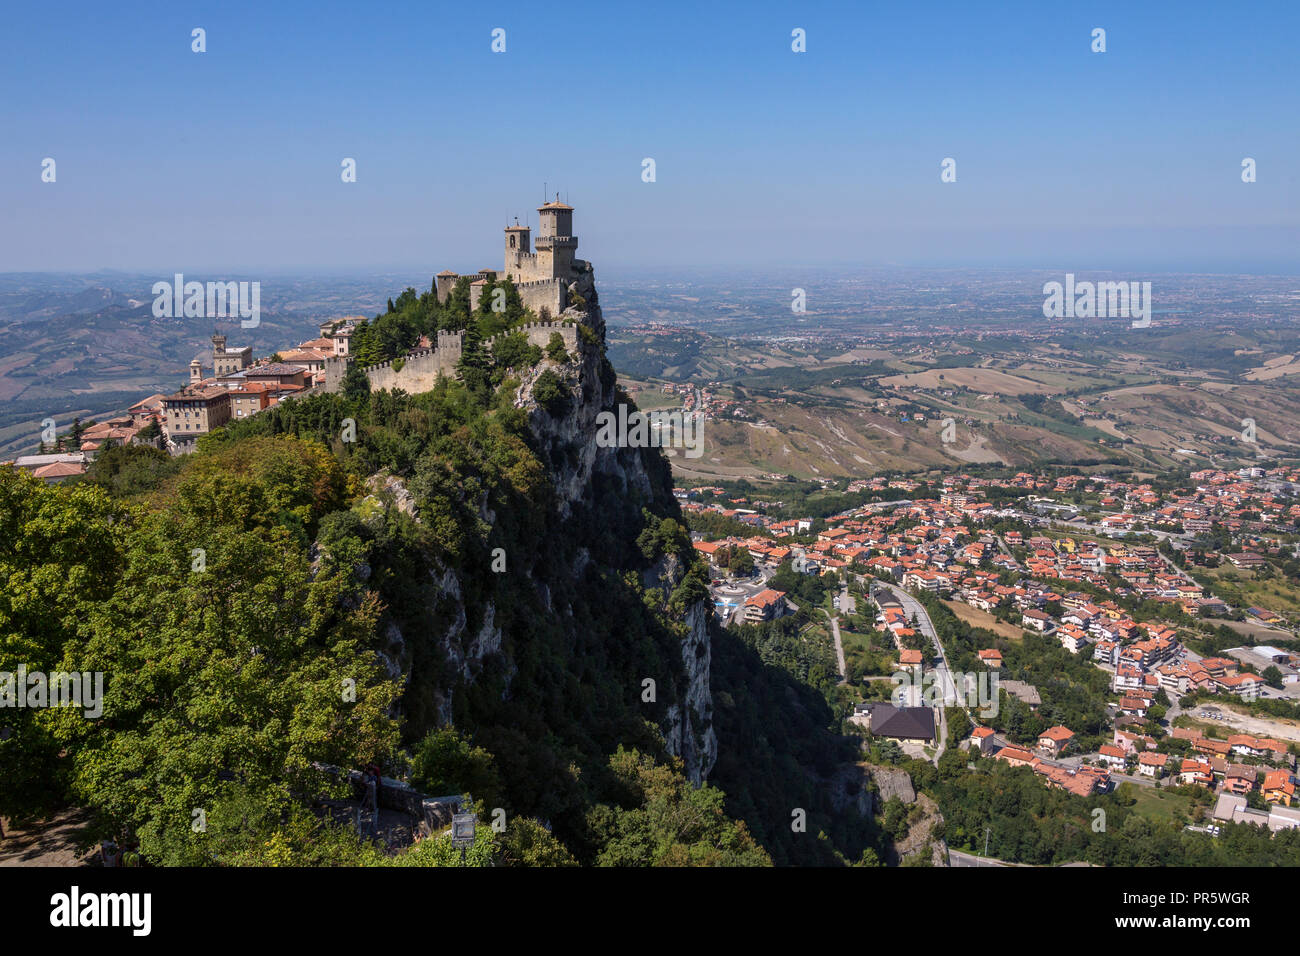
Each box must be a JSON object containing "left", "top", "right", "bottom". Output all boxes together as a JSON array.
[{"left": 0, "top": 297, "right": 872, "bottom": 865}]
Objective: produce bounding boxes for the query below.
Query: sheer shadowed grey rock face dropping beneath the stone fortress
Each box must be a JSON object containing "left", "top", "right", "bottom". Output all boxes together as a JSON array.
[{"left": 363, "top": 271, "right": 718, "bottom": 783}]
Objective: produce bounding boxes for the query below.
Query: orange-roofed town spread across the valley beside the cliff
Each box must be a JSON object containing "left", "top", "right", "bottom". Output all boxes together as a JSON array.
[{"left": 675, "top": 468, "right": 1300, "bottom": 831}]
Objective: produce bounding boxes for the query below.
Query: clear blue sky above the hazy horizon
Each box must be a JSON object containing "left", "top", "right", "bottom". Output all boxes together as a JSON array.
[{"left": 0, "top": 0, "right": 1300, "bottom": 274}]
